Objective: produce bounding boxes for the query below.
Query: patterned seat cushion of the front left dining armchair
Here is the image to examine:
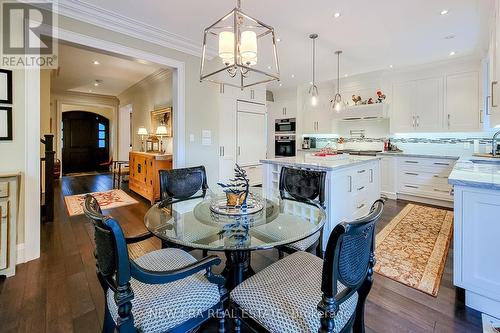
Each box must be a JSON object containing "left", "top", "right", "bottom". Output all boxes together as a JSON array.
[{"left": 107, "top": 248, "right": 220, "bottom": 332}]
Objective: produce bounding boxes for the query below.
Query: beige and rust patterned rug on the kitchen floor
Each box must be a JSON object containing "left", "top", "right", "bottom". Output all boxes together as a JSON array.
[{"left": 375, "top": 204, "right": 453, "bottom": 297}]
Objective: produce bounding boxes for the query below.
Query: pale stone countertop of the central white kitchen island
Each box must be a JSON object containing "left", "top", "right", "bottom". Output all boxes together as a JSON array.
[{"left": 260, "top": 155, "right": 380, "bottom": 171}]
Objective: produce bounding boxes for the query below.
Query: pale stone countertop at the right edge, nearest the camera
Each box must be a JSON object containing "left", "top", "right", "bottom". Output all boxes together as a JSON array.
[{"left": 448, "top": 157, "right": 500, "bottom": 191}]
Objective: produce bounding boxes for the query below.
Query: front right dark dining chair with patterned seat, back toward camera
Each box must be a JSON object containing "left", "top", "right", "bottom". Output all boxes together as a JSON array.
[{"left": 230, "top": 200, "right": 384, "bottom": 333}]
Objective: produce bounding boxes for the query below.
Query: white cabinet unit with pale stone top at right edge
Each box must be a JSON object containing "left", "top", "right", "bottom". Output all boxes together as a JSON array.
[{"left": 448, "top": 157, "right": 500, "bottom": 318}]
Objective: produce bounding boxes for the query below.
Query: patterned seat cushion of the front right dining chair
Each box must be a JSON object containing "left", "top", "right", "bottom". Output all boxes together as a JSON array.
[{"left": 231, "top": 252, "right": 358, "bottom": 333}]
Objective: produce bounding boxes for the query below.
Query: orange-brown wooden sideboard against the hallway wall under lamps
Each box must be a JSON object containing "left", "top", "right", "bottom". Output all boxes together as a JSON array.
[{"left": 129, "top": 151, "right": 172, "bottom": 204}]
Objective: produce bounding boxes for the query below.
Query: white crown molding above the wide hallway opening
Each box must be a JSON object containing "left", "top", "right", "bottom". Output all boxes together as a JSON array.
[{"left": 56, "top": 0, "right": 205, "bottom": 57}]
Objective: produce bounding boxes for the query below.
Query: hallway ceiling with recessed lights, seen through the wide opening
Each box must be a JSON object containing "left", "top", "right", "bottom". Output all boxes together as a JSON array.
[{"left": 51, "top": 44, "right": 159, "bottom": 96}]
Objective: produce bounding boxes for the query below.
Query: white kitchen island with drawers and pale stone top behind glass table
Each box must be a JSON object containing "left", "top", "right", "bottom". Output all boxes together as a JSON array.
[{"left": 260, "top": 155, "right": 380, "bottom": 251}]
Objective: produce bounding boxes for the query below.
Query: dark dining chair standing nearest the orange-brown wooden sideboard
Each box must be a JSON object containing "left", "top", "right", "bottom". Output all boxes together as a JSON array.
[{"left": 159, "top": 166, "right": 208, "bottom": 257}]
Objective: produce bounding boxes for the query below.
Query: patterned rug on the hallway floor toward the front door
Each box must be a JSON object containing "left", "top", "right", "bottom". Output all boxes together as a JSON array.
[{"left": 64, "top": 190, "right": 137, "bottom": 216}]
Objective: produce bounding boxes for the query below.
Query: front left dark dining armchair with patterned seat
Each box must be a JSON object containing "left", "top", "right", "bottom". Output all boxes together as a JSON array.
[{"left": 84, "top": 195, "right": 226, "bottom": 333}]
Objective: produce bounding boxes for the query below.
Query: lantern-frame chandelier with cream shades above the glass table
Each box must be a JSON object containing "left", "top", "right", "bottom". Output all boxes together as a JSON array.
[{"left": 200, "top": 0, "right": 280, "bottom": 90}]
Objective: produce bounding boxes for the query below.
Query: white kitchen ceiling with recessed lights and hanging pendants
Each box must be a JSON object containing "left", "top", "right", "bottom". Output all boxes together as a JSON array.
[{"left": 61, "top": 0, "right": 491, "bottom": 86}]
